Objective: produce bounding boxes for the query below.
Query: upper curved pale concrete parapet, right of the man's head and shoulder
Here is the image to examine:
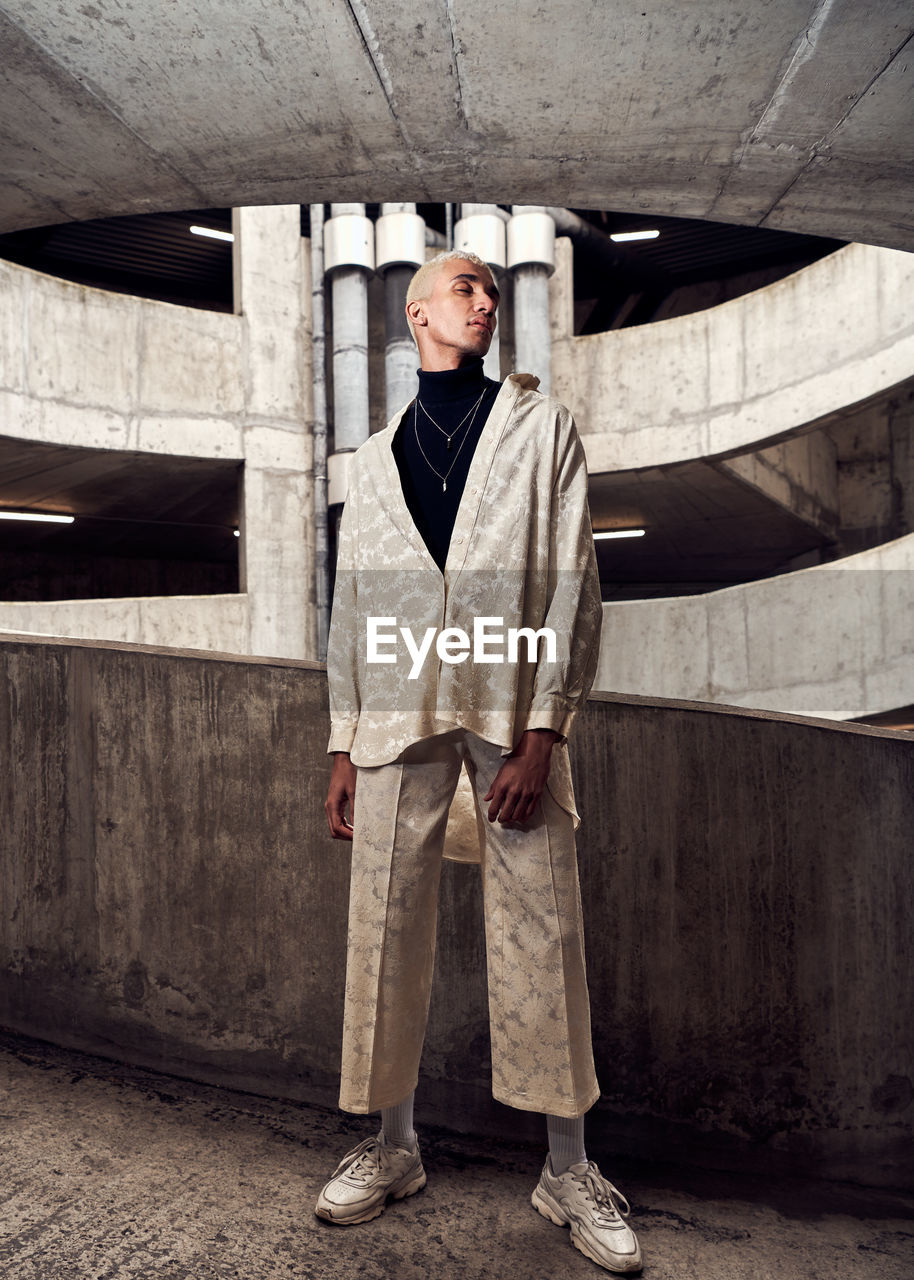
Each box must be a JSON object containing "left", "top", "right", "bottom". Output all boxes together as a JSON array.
[{"left": 552, "top": 244, "right": 914, "bottom": 472}]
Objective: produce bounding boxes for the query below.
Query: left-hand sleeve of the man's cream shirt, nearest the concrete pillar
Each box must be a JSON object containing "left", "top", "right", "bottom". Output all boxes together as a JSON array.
[{"left": 326, "top": 465, "right": 361, "bottom": 754}]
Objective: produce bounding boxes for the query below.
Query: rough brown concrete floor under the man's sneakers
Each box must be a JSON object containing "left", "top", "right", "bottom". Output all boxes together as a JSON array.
[{"left": 0, "top": 1034, "right": 914, "bottom": 1280}]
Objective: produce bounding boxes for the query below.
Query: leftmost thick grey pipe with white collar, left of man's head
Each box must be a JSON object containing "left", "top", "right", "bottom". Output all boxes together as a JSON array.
[{"left": 324, "top": 205, "right": 374, "bottom": 452}]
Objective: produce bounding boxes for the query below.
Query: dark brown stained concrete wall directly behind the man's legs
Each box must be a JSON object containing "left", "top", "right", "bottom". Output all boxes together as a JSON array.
[{"left": 0, "top": 637, "right": 914, "bottom": 1185}]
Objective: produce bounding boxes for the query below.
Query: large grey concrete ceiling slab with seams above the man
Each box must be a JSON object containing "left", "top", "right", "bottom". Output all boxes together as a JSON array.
[{"left": 0, "top": 0, "right": 914, "bottom": 250}]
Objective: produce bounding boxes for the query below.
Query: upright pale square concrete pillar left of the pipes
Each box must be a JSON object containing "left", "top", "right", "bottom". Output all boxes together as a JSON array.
[{"left": 232, "top": 205, "right": 316, "bottom": 658}]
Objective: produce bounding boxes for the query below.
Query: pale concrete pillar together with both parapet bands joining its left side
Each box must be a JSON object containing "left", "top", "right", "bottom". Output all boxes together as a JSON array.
[{"left": 0, "top": 205, "right": 316, "bottom": 658}]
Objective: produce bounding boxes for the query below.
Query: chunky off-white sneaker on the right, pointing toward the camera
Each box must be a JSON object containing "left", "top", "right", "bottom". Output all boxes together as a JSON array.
[{"left": 531, "top": 1156, "right": 641, "bottom": 1271}]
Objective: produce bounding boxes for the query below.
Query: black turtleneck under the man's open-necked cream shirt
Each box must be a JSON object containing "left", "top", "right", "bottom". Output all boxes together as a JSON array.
[{"left": 392, "top": 356, "right": 502, "bottom": 572}]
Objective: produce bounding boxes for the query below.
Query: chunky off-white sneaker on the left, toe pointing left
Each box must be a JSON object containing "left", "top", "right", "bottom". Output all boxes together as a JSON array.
[{"left": 314, "top": 1134, "right": 425, "bottom": 1226}]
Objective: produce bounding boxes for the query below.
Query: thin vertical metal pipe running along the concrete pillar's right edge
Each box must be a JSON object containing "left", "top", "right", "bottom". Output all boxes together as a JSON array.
[{"left": 310, "top": 205, "right": 330, "bottom": 662}]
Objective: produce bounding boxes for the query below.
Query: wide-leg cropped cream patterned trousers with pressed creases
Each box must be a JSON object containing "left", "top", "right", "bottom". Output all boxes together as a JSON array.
[{"left": 339, "top": 728, "right": 599, "bottom": 1116}]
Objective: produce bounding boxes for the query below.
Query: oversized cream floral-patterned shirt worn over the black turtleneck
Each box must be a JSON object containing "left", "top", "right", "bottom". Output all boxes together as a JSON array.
[{"left": 328, "top": 374, "right": 603, "bottom": 860}]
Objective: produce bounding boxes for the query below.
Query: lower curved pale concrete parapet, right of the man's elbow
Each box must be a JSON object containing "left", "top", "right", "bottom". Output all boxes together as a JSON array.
[{"left": 594, "top": 524, "right": 914, "bottom": 719}]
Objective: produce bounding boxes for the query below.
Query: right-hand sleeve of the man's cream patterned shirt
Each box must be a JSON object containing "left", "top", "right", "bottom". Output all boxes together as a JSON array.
[{"left": 524, "top": 415, "right": 603, "bottom": 739}]
